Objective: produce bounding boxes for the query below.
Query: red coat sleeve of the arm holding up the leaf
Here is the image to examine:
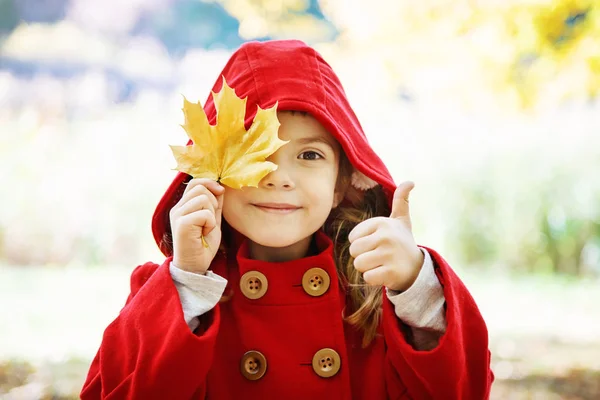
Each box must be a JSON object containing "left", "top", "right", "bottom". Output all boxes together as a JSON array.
[{"left": 81, "top": 259, "right": 220, "bottom": 400}]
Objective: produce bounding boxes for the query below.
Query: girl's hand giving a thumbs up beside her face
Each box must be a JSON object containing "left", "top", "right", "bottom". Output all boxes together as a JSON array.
[{"left": 348, "top": 182, "right": 423, "bottom": 291}]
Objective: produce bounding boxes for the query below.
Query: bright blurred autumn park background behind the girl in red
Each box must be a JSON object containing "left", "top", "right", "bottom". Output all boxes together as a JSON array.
[{"left": 0, "top": 0, "right": 600, "bottom": 399}]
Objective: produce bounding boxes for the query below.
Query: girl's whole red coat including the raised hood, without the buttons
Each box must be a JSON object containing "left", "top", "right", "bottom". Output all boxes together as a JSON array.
[{"left": 81, "top": 41, "right": 493, "bottom": 400}]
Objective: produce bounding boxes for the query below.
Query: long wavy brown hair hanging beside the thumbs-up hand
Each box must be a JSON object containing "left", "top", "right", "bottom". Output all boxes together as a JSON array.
[{"left": 325, "top": 151, "right": 389, "bottom": 347}]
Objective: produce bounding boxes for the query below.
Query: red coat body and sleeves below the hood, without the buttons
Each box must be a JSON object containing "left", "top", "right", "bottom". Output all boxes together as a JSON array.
[{"left": 81, "top": 230, "right": 493, "bottom": 400}]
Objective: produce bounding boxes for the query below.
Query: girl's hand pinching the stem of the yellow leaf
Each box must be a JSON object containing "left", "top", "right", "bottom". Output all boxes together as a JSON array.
[{"left": 169, "top": 178, "right": 225, "bottom": 274}]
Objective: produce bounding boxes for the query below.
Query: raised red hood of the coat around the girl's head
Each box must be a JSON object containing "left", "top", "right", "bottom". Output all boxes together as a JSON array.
[{"left": 152, "top": 40, "right": 396, "bottom": 255}]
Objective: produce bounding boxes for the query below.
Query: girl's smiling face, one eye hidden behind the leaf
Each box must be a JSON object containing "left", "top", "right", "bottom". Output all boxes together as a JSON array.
[{"left": 223, "top": 112, "right": 343, "bottom": 258}]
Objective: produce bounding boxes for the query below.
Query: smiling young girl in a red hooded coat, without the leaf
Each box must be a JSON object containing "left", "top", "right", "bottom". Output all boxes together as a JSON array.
[{"left": 81, "top": 41, "right": 493, "bottom": 400}]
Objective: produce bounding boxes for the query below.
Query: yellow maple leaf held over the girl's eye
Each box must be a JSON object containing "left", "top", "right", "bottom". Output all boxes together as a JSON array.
[{"left": 171, "top": 78, "right": 287, "bottom": 189}]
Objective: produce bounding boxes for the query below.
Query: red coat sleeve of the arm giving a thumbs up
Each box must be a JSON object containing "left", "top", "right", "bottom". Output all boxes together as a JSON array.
[{"left": 382, "top": 249, "right": 494, "bottom": 400}]
